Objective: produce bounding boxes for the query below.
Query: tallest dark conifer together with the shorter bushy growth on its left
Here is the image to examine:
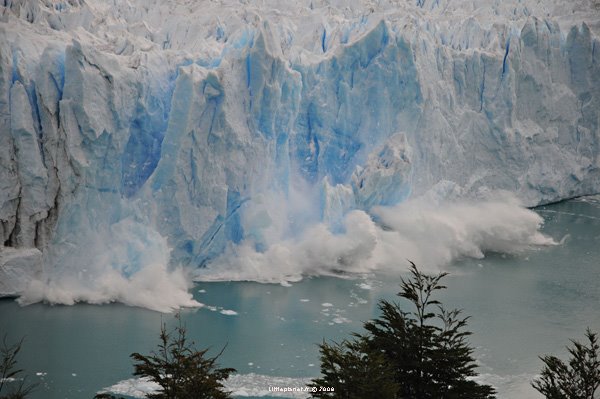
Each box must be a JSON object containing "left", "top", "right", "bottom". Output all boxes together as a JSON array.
[{"left": 312, "top": 262, "right": 495, "bottom": 399}]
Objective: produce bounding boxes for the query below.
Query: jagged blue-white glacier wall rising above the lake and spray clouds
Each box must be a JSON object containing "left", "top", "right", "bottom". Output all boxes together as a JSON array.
[{"left": 0, "top": 0, "right": 600, "bottom": 309}]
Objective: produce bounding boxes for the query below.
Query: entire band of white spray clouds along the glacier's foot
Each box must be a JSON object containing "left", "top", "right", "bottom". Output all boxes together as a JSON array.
[{"left": 19, "top": 182, "right": 556, "bottom": 312}]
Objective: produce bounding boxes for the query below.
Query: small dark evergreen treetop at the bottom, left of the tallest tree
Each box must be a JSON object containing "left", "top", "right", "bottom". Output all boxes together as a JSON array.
[{"left": 131, "top": 320, "right": 235, "bottom": 399}]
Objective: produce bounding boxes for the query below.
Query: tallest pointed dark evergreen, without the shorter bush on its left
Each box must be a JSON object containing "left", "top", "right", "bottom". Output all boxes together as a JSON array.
[{"left": 365, "top": 262, "right": 494, "bottom": 399}]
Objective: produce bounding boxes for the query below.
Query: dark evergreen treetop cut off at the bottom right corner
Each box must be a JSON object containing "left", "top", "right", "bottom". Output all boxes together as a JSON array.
[{"left": 531, "top": 328, "right": 600, "bottom": 399}]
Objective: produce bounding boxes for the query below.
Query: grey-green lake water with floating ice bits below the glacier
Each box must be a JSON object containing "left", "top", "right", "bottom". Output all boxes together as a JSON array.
[{"left": 0, "top": 197, "right": 600, "bottom": 399}]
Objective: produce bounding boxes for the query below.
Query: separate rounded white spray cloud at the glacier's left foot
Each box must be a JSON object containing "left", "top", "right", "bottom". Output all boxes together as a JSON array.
[{"left": 19, "top": 219, "right": 199, "bottom": 312}]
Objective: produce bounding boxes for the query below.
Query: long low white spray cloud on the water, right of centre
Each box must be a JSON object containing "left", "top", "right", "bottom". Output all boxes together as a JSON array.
[{"left": 196, "top": 193, "right": 557, "bottom": 283}]
